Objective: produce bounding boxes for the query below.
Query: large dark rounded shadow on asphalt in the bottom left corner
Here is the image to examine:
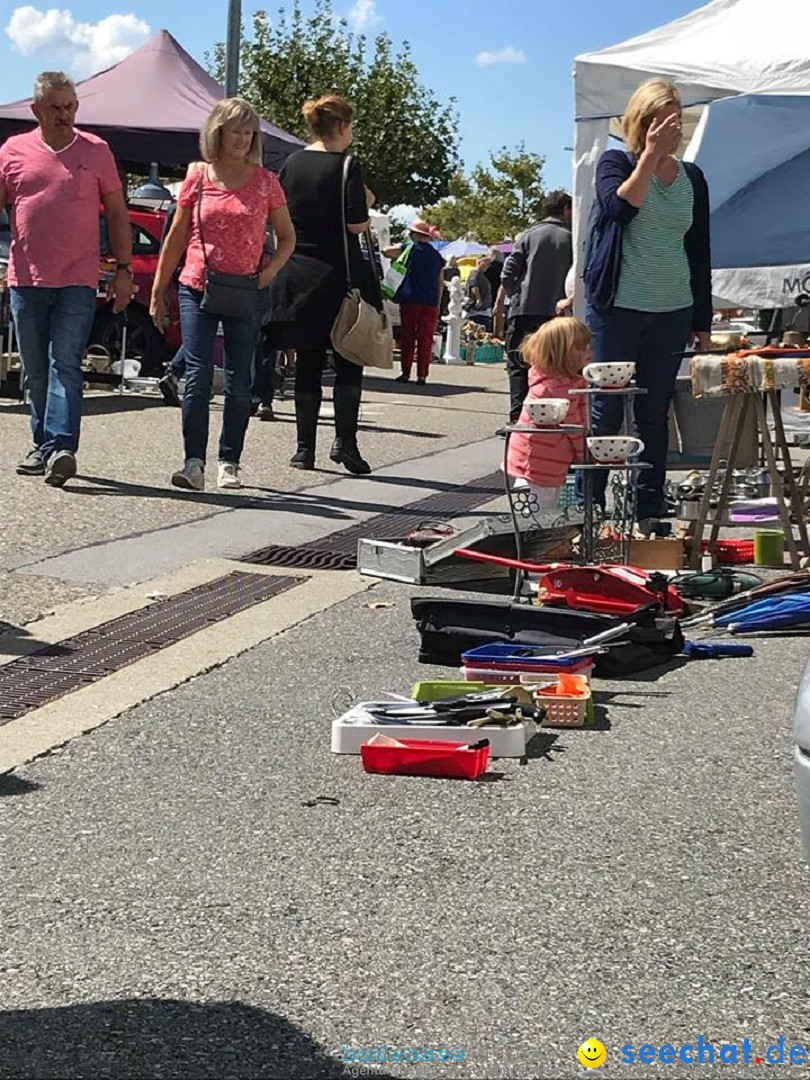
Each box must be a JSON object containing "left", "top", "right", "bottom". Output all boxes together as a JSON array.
[{"left": 0, "top": 998, "right": 393, "bottom": 1080}]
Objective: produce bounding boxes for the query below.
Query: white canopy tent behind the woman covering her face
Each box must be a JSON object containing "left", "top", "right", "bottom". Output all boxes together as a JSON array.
[{"left": 573, "top": 0, "right": 810, "bottom": 309}]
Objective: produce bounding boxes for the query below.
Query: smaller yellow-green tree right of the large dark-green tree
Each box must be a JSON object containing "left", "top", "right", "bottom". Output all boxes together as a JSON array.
[{"left": 422, "top": 143, "right": 546, "bottom": 244}]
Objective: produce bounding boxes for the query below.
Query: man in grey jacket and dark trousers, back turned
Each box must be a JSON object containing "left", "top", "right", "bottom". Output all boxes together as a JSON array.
[{"left": 501, "top": 191, "right": 573, "bottom": 423}]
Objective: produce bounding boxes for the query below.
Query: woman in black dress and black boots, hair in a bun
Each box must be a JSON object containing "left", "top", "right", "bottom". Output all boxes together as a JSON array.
[{"left": 268, "top": 94, "right": 381, "bottom": 474}]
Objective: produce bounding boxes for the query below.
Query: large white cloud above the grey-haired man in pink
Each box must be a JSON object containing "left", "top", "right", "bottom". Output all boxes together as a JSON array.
[{"left": 5, "top": 4, "right": 151, "bottom": 76}]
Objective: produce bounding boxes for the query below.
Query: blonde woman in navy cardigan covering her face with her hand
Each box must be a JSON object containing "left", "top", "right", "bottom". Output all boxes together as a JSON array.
[{"left": 584, "top": 79, "right": 712, "bottom": 522}]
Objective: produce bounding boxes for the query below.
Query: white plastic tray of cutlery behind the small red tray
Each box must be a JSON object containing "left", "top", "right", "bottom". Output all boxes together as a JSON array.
[{"left": 332, "top": 701, "right": 538, "bottom": 757}]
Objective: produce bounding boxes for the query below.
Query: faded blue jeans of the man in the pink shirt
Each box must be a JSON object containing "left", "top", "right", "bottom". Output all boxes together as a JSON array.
[{"left": 11, "top": 285, "right": 96, "bottom": 460}]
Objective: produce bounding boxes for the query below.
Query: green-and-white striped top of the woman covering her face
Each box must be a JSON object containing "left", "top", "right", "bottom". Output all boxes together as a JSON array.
[{"left": 613, "top": 162, "right": 694, "bottom": 311}]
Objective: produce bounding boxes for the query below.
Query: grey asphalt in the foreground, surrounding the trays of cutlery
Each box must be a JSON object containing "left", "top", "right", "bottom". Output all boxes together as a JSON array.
[{"left": 0, "top": 583, "right": 810, "bottom": 1080}]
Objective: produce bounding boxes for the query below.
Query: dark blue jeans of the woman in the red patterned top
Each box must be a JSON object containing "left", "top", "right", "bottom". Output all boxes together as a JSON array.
[{"left": 179, "top": 285, "right": 257, "bottom": 464}]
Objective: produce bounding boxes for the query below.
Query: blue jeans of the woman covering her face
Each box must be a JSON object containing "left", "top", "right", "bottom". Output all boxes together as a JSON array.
[{"left": 585, "top": 307, "right": 692, "bottom": 521}]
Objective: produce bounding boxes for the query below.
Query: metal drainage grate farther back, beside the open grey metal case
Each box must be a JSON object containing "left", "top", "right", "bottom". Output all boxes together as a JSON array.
[{"left": 240, "top": 472, "right": 503, "bottom": 570}]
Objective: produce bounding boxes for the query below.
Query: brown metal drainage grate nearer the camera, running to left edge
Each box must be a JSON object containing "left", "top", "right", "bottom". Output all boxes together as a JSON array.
[{"left": 0, "top": 571, "right": 307, "bottom": 724}]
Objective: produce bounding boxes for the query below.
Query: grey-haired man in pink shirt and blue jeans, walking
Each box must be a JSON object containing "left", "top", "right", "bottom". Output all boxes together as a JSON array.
[{"left": 0, "top": 71, "right": 133, "bottom": 487}]
